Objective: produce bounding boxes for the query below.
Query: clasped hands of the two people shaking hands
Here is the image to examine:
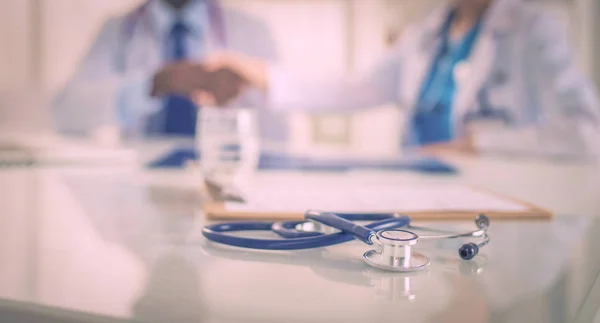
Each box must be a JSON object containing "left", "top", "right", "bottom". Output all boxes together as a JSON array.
[{"left": 150, "top": 54, "right": 266, "bottom": 106}]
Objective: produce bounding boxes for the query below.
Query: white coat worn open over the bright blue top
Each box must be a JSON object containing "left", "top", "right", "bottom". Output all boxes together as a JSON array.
[{"left": 269, "top": 0, "right": 600, "bottom": 156}]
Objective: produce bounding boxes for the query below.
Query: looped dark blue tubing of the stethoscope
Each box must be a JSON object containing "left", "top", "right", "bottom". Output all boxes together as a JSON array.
[{"left": 202, "top": 212, "right": 410, "bottom": 250}]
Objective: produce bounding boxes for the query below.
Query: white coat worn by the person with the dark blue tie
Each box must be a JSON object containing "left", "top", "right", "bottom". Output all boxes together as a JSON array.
[{"left": 53, "top": 0, "right": 287, "bottom": 140}]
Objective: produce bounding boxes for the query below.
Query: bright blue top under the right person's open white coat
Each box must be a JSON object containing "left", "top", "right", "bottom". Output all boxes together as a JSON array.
[{"left": 413, "top": 12, "right": 481, "bottom": 145}]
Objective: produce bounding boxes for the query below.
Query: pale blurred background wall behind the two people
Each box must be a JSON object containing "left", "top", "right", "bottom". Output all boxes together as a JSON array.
[{"left": 0, "top": 0, "right": 600, "bottom": 155}]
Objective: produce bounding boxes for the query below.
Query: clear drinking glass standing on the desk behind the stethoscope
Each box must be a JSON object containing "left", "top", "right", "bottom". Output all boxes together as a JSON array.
[{"left": 196, "top": 107, "right": 260, "bottom": 187}]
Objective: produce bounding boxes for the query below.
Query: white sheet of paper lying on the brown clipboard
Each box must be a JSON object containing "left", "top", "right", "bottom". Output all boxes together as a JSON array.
[{"left": 225, "top": 185, "right": 528, "bottom": 213}]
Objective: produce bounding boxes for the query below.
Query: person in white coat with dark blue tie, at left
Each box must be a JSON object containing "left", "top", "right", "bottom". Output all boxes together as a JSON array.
[{"left": 53, "top": 0, "right": 286, "bottom": 139}]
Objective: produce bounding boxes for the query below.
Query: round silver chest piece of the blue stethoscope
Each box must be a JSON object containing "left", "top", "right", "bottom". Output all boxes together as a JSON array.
[{"left": 363, "top": 230, "right": 430, "bottom": 272}]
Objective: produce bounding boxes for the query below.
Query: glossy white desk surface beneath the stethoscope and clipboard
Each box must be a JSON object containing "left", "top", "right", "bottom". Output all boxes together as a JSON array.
[{"left": 0, "top": 145, "right": 600, "bottom": 323}]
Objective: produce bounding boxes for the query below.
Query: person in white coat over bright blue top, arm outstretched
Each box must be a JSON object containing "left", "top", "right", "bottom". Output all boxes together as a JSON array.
[{"left": 204, "top": 0, "right": 600, "bottom": 156}]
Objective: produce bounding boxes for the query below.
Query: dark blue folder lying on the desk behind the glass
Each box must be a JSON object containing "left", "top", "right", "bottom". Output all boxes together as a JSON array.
[{"left": 148, "top": 148, "right": 458, "bottom": 174}]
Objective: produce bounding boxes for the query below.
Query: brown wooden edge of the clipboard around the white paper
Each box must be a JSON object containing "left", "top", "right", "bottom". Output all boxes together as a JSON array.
[{"left": 202, "top": 185, "right": 554, "bottom": 221}]
